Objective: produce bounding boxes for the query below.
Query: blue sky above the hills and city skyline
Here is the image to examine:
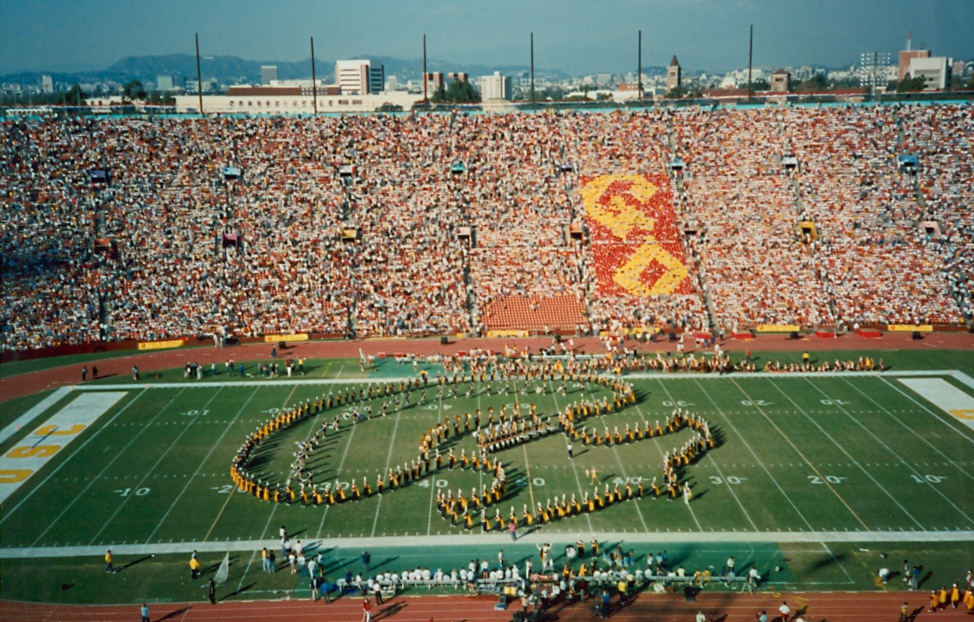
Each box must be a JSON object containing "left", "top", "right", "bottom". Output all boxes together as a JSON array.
[{"left": 0, "top": 0, "right": 974, "bottom": 74}]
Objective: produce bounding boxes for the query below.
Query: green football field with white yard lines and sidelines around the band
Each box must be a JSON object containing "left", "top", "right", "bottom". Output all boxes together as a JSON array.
[{"left": 0, "top": 359, "right": 974, "bottom": 608}]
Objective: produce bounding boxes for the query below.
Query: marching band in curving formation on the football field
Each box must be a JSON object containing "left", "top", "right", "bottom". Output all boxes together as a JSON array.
[{"left": 231, "top": 360, "right": 714, "bottom": 531}]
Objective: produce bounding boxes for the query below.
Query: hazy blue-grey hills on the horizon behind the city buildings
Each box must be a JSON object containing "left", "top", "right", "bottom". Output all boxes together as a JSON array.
[{"left": 0, "top": 54, "right": 580, "bottom": 85}]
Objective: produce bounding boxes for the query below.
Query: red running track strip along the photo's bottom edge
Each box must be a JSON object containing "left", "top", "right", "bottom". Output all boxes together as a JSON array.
[{"left": 0, "top": 591, "right": 974, "bottom": 622}]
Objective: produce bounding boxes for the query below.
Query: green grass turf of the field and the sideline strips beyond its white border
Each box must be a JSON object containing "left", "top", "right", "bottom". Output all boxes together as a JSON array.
[{"left": 0, "top": 352, "right": 974, "bottom": 602}]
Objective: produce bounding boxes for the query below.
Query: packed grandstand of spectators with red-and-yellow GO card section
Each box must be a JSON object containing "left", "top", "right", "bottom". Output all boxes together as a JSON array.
[{"left": 0, "top": 104, "right": 974, "bottom": 350}]
